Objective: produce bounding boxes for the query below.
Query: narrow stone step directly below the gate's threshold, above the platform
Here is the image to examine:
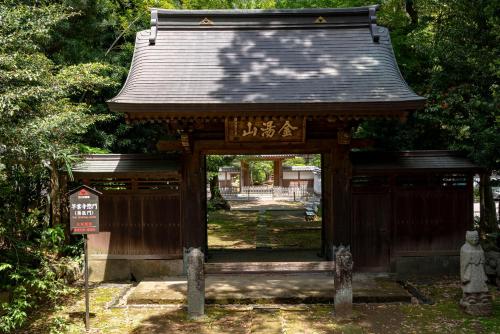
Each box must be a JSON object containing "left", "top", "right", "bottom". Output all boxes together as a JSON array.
[{"left": 205, "top": 261, "right": 335, "bottom": 275}]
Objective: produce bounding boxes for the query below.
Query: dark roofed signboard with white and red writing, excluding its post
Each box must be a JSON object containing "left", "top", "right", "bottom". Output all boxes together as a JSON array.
[{"left": 69, "top": 186, "right": 100, "bottom": 234}]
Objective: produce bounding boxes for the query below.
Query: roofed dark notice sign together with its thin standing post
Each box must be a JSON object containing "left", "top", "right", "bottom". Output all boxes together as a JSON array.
[{"left": 69, "top": 186, "right": 101, "bottom": 331}]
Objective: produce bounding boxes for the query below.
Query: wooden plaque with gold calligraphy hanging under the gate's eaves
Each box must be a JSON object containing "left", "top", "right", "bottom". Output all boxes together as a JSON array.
[{"left": 226, "top": 117, "right": 306, "bottom": 143}]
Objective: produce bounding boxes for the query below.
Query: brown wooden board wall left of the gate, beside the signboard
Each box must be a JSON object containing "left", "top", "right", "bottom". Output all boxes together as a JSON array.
[{"left": 89, "top": 190, "right": 182, "bottom": 258}]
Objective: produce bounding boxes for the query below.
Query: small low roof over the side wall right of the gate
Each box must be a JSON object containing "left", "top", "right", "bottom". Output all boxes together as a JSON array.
[{"left": 351, "top": 151, "right": 481, "bottom": 174}]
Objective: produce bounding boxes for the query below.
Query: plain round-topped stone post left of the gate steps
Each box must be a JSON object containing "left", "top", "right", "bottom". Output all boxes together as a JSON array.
[{"left": 187, "top": 248, "right": 205, "bottom": 319}]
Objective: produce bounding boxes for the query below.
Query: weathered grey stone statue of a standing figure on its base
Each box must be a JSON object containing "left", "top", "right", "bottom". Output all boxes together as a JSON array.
[{"left": 460, "top": 231, "right": 492, "bottom": 316}]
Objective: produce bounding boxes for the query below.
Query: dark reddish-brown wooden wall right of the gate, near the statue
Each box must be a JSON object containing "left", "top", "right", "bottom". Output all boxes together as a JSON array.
[{"left": 351, "top": 175, "right": 473, "bottom": 270}]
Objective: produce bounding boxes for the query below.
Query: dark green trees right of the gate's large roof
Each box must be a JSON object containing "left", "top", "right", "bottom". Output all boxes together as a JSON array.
[{"left": 356, "top": 0, "right": 500, "bottom": 169}]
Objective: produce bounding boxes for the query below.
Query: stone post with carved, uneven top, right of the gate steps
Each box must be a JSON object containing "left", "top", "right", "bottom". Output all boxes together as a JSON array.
[{"left": 334, "top": 246, "right": 353, "bottom": 317}]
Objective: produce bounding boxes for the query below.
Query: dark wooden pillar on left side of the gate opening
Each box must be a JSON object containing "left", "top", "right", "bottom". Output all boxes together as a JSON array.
[{"left": 181, "top": 149, "right": 207, "bottom": 250}]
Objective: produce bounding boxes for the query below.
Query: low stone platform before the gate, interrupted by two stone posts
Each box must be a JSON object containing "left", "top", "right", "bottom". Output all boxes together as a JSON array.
[{"left": 127, "top": 273, "right": 411, "bottom": 304}]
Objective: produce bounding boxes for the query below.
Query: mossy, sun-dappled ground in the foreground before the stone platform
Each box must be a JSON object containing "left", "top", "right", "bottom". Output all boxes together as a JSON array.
[{"left": 19, "top": 278, "right": 500, "bottom": 334}]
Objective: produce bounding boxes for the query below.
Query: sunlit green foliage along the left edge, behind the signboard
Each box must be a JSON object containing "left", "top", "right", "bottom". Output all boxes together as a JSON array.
[{"left": 0, "top": 3, "right": 119, "bottom": 332}]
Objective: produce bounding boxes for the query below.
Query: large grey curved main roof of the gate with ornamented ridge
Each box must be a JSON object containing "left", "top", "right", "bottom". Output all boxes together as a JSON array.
[{"left": 108, "top": 6, "right": 425, "bottom": 117}]
